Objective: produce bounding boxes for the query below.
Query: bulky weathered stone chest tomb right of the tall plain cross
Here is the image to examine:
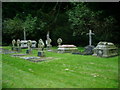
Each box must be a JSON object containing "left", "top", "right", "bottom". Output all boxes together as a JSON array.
[{"left": 93, "top": 42, "right": 118, "bottom": 57}]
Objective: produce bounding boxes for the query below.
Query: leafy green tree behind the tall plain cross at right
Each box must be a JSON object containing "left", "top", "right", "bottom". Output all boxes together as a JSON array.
[{"left": 67, "top": 3, "right": 116, "bottom": 43}]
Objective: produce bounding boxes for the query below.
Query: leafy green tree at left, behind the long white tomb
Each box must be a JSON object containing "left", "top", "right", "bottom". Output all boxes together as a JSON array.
[{"left": 3, "top": 14, "right": 37, "bottom": 44}]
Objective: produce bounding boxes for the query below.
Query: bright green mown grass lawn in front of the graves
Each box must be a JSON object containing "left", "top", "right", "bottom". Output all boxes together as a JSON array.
[{"left": 2, "top": 47, "right": 118, "bottom": 88}]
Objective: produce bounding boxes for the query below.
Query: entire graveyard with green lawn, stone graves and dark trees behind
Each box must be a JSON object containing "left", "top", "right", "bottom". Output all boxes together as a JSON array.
[{"left": 0, "top": 2, "right": 120, "bottom": 88}]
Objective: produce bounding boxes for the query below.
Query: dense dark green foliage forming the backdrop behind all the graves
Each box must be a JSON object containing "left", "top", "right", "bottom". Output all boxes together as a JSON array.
[{"left": 2, "top": 2, "right": 120, "bottom": 46}]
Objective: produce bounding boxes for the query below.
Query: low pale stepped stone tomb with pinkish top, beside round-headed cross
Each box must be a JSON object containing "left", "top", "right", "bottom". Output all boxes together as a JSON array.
[{"left": 58, "top": 45, "right": 78, "bottom": 53}]
